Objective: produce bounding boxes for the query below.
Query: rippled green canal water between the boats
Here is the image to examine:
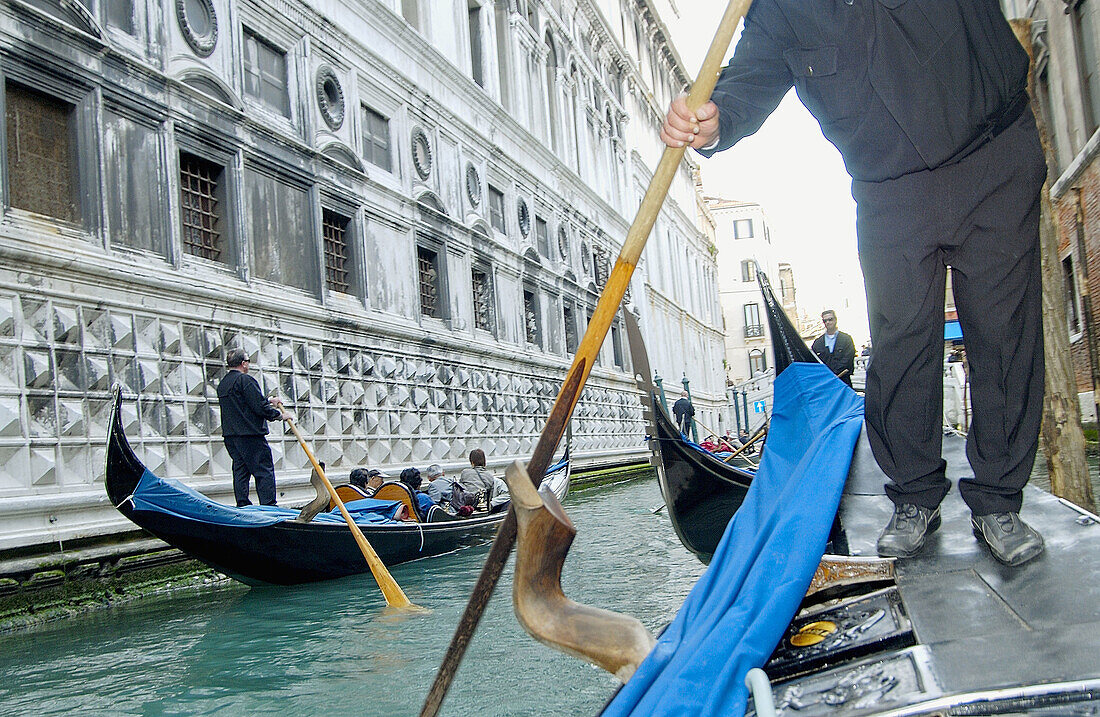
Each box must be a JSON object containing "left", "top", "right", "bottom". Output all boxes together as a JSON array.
[{"left": 0, "top": 479, "right": 703, "bottom": 716}]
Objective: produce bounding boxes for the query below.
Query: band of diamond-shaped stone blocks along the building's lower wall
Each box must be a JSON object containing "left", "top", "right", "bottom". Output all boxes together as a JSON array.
[{"left": 0, "top": 293, "right": 645, "bottom": 495}]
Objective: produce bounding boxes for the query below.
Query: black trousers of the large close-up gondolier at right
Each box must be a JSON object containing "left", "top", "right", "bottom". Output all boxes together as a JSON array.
[{"left": 853, "top": 110, "right": 1046, "bottom": 516}]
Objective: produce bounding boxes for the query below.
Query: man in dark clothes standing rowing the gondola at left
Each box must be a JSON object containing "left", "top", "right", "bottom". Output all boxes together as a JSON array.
[{"left": 218, "top": 349, "right": 287, "bottom": 508}]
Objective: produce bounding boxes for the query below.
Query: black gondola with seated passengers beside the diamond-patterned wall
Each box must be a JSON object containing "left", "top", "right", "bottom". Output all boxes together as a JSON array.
[{"left": 106, "top": 389, "right": 570, "bottom": 585}]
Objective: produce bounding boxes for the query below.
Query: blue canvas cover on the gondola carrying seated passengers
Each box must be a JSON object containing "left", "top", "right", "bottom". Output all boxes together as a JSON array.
[{"left": 130, "top": 470, "right": 402, "bottom": 527}]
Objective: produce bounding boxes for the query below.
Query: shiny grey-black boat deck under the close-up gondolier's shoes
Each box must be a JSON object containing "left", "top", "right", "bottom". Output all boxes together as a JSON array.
[{"left": 796, "top": 435, "right": 1100, "bottom": 714}]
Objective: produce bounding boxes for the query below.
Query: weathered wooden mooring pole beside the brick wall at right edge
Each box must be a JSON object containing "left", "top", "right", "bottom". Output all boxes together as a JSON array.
[{"left": 1012, "top": 20, "right": 1096, "bottom": 511}]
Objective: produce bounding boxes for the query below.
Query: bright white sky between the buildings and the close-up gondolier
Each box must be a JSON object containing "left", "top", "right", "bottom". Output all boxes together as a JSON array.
[{"left": 669, "top": 0, "right": 870, "bottom": 346}]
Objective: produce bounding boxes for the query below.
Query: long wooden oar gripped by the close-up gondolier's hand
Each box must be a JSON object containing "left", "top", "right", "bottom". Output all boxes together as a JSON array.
[{"left": 420, "top": 5, "right": 750, "bottom": 717}]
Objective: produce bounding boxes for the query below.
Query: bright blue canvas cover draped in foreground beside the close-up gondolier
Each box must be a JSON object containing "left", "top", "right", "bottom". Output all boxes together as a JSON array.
[{"left": 603, "top": 363, "right": 864, "bottom": 716}]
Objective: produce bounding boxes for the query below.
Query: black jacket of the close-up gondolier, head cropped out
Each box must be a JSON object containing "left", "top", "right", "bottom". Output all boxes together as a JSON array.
[{"left": 702, "top": 0, "right": 1027, "bottom": 181}]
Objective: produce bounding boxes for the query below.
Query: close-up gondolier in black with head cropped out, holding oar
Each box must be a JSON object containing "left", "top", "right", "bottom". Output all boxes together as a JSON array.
[{"left": 661, "top": 0, "right": 1046, "bottom": 565}]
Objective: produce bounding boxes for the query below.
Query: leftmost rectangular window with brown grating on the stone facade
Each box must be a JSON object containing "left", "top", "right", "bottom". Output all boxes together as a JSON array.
[{"left": 6, "top": 82, "right": 80, "bottom": 222}]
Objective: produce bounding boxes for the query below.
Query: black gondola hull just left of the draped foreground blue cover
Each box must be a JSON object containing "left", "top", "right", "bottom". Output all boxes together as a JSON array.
[{"left": 635, "top": 398, "right": 754, "bottom": 562}]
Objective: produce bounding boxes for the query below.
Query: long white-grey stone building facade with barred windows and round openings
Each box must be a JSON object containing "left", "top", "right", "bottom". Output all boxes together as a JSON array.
[{"left": 0, "top": 0, "right": 724, "bottom": 555}]
